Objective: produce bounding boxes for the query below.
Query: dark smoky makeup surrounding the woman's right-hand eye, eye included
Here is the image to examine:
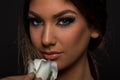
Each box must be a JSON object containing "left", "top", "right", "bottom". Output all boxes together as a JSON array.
[{"left": 57, "top": 16, "right": 76, "bottom": 26}]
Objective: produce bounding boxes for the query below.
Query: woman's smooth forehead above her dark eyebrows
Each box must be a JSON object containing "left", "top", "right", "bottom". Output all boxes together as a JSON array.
[{"left": 29, "top": 0, "right": 79, "bottom": 14}]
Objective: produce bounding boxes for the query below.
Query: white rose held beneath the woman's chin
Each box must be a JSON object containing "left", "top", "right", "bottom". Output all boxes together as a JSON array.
[{"left": 28, "top": 59, "right": 58, "bottom": 80}]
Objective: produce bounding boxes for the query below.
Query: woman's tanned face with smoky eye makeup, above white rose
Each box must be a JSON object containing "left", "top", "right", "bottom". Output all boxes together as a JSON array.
[{"left": 29, "top": 0, "right": 99, "bottom": 69}]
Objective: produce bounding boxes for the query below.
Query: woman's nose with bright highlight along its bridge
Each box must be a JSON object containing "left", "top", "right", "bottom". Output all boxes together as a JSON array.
[{"left": 42, "top": 26, "right": 56, "bottom": 47}]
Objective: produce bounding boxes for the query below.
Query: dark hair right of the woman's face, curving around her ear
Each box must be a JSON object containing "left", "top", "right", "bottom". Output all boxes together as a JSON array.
[{"left": 70, "top": 0, "right": 107, "bottom": 50}]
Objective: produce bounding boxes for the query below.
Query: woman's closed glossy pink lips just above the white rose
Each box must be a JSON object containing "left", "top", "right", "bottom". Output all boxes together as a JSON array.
[{"left": 41, "top": 51, "right": 63, "bottom": 60}]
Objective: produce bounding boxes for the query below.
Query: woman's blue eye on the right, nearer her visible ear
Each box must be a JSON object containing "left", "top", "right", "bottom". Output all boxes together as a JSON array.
[{"left": 57, "top": 17, "right": 75, "bottom": 26}]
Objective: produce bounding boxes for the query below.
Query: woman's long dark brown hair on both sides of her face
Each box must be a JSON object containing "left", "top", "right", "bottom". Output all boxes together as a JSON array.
[{"left": 18, "top": 0, "right": 107, "bottom": 74}]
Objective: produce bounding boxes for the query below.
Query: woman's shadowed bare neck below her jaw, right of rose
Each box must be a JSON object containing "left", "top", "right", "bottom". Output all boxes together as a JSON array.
[{"left": 58, "top": 54, "right": 93, "bottom": 80}]
